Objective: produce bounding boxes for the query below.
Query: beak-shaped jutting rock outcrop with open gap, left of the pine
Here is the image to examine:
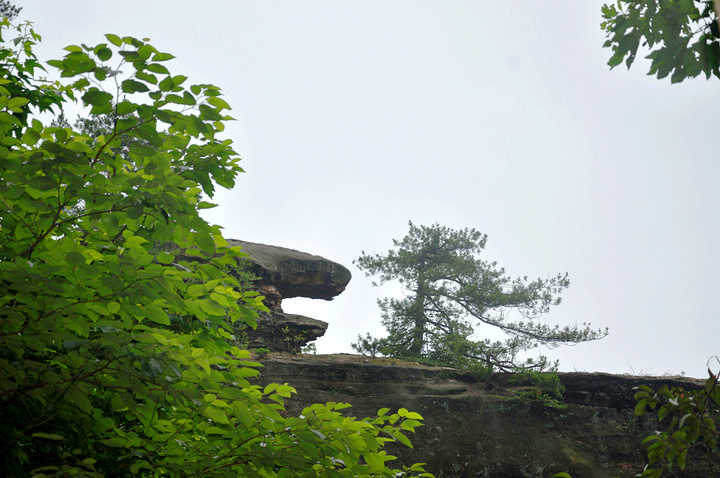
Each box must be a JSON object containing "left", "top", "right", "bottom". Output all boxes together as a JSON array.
[{"left": 228, "top": 239, "right": 352, "bottom": 352}]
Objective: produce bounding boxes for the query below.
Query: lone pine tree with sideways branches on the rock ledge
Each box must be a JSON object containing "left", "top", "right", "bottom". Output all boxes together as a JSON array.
[{"left": 353, "top": 222, "right": 607, "bottom": 371}]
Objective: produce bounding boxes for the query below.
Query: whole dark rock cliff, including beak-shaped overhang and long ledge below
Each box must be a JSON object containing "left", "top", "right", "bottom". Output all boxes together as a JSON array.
[{"left": 228, "top": 241, "right": 709, "bottom": 478}]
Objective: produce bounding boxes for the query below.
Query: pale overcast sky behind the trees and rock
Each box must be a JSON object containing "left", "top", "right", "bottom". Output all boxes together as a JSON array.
[{"left": 14, "top": 0, "right": 720, "bottom": 378}]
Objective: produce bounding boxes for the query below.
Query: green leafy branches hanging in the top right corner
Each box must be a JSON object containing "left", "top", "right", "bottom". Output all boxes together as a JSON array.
[{"left": 601, "top": 0, "right": 720, "bottom": 83}]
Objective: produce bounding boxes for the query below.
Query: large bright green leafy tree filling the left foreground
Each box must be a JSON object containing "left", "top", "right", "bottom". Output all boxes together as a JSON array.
[{"left": 0, "top": 19, "right": 430, "bottom": 477}]
